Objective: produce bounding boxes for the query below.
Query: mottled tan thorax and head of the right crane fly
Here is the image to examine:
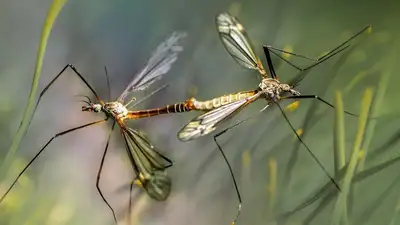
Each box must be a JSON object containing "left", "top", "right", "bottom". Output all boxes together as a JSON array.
[{"left": 259, "top": 78, "right": 300, "bottom": 100}]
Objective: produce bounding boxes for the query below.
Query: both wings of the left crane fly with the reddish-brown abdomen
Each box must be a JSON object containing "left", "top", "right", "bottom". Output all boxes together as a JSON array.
[{"left": 118, "top": 32, "right": 186, "bottom": 201}]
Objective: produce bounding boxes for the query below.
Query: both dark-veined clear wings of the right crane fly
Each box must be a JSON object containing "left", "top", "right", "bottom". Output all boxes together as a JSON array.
[{"left": 178, "top": 13, "right": 266, "bottom": 141}]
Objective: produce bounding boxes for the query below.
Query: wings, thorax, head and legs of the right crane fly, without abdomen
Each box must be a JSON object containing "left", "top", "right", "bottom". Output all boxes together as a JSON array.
[{"left": 177, "top": 13, "right": 370, "bottom": 224}]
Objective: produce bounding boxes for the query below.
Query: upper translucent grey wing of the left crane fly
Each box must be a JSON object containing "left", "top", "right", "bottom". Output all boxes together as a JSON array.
[{"left": 118, "top": 32, "right": 186, "bottom": 102}]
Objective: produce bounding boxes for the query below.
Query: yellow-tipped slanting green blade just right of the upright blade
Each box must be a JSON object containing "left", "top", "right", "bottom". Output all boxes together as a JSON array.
[{"left": 331, "top": 88, "right": 372, "bottom": 225}]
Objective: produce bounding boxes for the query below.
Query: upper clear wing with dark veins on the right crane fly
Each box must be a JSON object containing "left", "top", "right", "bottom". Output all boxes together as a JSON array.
[{"left": 216, "top": 13, "right": 265, "bottom": 74}]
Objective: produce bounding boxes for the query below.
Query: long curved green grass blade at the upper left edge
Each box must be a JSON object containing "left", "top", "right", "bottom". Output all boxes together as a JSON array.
[{"left": 1, "top": 0, "right": 67, "bottom": 171}]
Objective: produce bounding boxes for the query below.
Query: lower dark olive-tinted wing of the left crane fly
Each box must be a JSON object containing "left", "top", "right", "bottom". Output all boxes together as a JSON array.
[{"left": 121, "top": 128, "right": 172, "bottom": 201}]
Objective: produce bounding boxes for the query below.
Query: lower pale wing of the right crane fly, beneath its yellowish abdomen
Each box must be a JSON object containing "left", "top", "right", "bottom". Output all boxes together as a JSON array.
[{"left": 178, "top": 94, "right": 260, "bottom": 141}]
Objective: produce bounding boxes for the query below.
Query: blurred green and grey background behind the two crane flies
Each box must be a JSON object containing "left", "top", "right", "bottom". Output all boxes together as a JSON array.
[{"left": 0, "top": 0, "right": 400, "bottom": 225}]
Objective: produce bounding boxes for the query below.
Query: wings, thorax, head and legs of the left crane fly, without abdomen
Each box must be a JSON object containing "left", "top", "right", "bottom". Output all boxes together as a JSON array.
[{"left": 0, "top": 32, "right": 186, "bottom": 223}]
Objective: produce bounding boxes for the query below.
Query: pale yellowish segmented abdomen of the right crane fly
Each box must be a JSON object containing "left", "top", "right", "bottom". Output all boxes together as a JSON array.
[{"left": 191, "top": 90, "right": 257, "bottom": 111}]
